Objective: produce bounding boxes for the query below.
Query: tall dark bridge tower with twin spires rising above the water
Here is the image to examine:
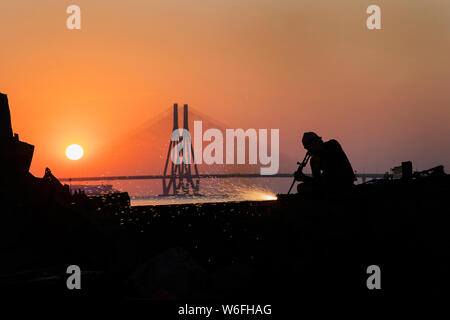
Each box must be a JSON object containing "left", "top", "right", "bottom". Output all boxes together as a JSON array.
[{"left": 163, "top": 103, "right": 200, "bottom": 196}]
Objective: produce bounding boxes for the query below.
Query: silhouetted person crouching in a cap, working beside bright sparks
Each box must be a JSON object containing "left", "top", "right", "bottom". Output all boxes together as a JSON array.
[{"left": 294, "top": 132, "right": 356, "bottom": 193}]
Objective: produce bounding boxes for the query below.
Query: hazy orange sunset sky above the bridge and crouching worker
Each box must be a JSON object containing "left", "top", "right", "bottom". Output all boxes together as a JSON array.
[{"left": 0, "top": 0, "right": 450, "bottom": 177}]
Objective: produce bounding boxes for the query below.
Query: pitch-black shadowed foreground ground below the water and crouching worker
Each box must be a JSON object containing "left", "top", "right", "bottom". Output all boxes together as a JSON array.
[{"left": 0, "top": 170, "right": 450, "bottom": 304}]
